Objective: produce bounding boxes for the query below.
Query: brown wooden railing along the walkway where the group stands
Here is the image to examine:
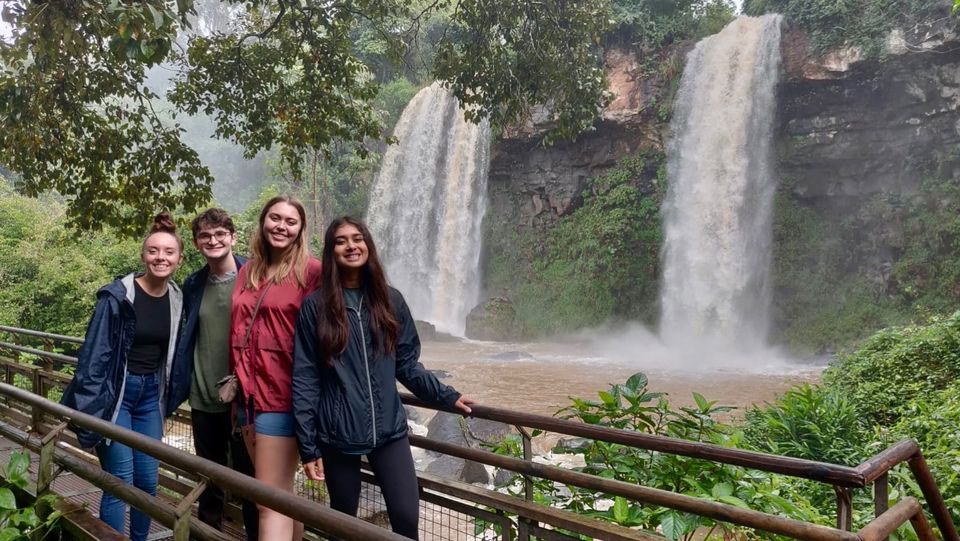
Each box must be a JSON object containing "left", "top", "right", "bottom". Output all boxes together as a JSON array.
[{"left": 0, "top": 326, "right": 960, "bottom": 541}]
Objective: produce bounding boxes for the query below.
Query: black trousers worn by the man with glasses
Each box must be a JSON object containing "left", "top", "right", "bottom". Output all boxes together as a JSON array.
[{"left": 190, "top": 410, "right": 260, "bottom": 541}]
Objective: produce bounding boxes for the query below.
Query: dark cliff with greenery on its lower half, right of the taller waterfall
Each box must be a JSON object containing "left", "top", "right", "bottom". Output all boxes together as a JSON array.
[{"left": 774, "top": 7, "right": 960, "bottom": 340}]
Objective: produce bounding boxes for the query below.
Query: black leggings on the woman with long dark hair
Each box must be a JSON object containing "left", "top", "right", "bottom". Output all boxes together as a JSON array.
[{"left": 320, "top": 436, "right": 420, "bottom": 539}]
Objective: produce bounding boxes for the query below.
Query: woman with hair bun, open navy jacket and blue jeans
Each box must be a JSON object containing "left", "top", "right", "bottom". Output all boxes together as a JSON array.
[{"left": 61, "top": 212, "right": 189, "bottom": 541}]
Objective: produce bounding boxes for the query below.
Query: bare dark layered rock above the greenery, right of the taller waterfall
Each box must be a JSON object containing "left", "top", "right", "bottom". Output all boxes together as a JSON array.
[{"left": 778, "top": 13, "right": 960, "bottom": 211}]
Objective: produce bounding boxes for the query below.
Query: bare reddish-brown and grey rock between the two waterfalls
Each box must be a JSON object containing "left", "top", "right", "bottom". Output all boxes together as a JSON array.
[{"left": 482, "top": 50, "right": 682, "bottom": 296}]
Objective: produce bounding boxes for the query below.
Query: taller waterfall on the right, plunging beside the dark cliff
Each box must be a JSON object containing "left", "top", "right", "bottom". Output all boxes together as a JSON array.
[{"left": 660, "top": 15, "right": 781, "bottom": 352}]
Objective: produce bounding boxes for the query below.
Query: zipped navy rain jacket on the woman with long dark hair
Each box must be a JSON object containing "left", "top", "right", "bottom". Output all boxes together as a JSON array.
[{"left": 293, "top": 288, "right": 460, "bottom": 463}]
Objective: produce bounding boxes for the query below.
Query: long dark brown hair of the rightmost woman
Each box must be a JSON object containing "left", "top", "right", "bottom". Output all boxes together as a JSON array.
[{"left": 317, "top": 216, "right": 400, "bottom": 366}]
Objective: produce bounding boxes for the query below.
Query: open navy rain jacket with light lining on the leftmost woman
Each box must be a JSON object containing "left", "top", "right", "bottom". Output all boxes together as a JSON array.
[{"left": 60, "top": 274, "right": 190, "bottom": 447}]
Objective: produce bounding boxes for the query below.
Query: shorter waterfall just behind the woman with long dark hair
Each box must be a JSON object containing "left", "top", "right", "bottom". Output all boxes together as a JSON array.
[{"left": 367, "top": 83, "right": 490, "bottom": 336}]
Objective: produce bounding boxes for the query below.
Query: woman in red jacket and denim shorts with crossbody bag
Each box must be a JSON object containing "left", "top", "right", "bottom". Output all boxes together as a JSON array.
[{"left": 230, "top": 196, "right": 320, "bottom": 541}]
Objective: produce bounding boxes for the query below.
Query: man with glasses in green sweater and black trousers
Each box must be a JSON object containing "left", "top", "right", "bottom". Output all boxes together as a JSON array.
[{"left": 173, "top": 208, "right": 259, "bottom": 541}]
